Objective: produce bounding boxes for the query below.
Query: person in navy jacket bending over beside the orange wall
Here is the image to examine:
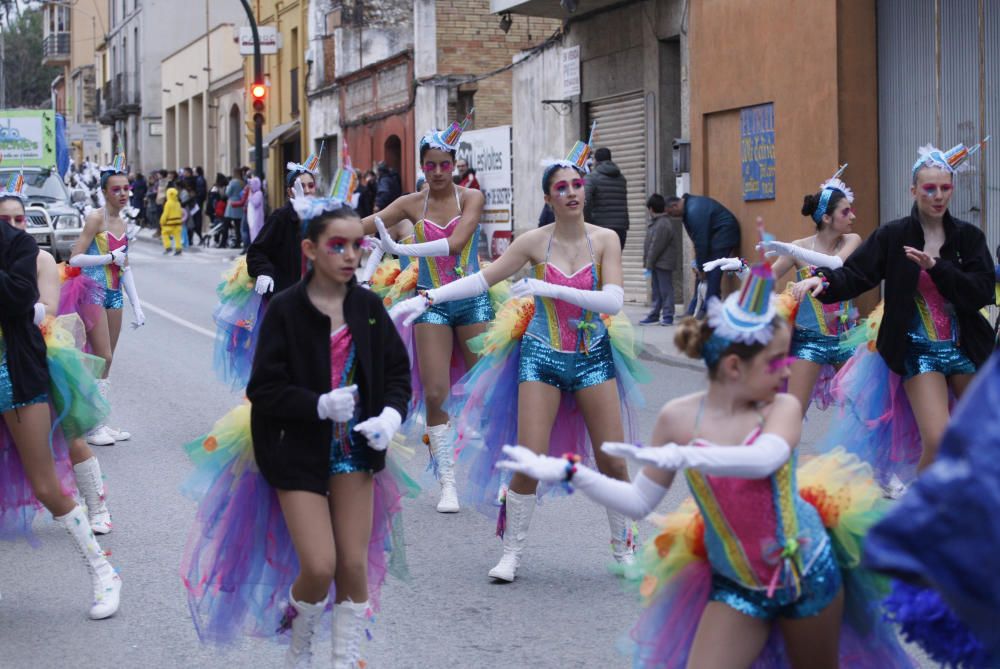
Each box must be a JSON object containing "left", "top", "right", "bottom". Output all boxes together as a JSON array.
[{"left": 667, "top": 195, "right": 740, "bottom": 303}]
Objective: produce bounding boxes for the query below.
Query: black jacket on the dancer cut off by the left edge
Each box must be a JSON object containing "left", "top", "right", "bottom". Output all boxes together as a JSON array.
[{"left": 0, "top": 223, "right": 49, "bottom": 404}]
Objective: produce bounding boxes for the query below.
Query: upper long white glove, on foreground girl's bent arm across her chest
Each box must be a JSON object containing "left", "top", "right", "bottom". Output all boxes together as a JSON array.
[{"left": 601, "top": 432, "right": 792, "bottom": 479}]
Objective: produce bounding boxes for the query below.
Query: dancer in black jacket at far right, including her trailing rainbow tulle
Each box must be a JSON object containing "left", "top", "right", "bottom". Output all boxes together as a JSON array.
[{"left": 793, "top": 140, "right": 995, "bottom": 488}]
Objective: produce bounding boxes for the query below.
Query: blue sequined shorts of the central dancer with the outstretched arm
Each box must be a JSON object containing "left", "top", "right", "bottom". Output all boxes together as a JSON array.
[{"left": 517, "top": 335, "right": 615, "bottom": 393}]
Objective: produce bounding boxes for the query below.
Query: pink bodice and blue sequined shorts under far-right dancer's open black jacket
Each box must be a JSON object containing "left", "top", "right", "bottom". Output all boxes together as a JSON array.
[{"left": 903, "top": 270, "right": 976, "bottom": 379}]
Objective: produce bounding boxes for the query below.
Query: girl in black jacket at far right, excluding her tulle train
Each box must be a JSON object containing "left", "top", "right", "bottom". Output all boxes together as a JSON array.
[{"left": 794, "top": 145, "right": 994, "bottom": 480}]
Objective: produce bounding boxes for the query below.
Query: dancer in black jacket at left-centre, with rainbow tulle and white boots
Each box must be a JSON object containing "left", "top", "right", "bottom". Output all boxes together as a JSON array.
[{"left": 181, "top": 197, "right": 416, "bottom": 667}]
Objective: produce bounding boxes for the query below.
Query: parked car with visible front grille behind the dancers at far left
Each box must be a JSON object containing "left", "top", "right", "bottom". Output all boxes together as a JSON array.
[{"left": 0, "top": 167, "right": 83, "bottom": 260}]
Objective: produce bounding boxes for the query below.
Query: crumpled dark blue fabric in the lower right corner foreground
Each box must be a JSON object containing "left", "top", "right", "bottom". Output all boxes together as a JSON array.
[{"left": 865, "top": 353, "right": 1000, "bottom": 656}]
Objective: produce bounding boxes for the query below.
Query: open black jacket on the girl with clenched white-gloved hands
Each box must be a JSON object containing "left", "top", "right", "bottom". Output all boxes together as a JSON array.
[{"left": 247, "top": 272, "right": 411, "bottom": 494}]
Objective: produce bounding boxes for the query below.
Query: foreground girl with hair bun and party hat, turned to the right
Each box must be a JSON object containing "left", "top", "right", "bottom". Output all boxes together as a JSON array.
[{"left": 499, "top": 243, "right": 912, "bottom": 669}]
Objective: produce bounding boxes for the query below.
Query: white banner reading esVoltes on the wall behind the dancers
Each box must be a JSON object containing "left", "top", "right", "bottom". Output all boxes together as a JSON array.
[{"left": 456, "top": 125, "right": 514, "bottom": 260}]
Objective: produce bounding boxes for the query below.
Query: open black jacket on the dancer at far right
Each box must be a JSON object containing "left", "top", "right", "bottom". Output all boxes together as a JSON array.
[{"left": 818, "top": 206, "right": 995, "bottom": 375}]
